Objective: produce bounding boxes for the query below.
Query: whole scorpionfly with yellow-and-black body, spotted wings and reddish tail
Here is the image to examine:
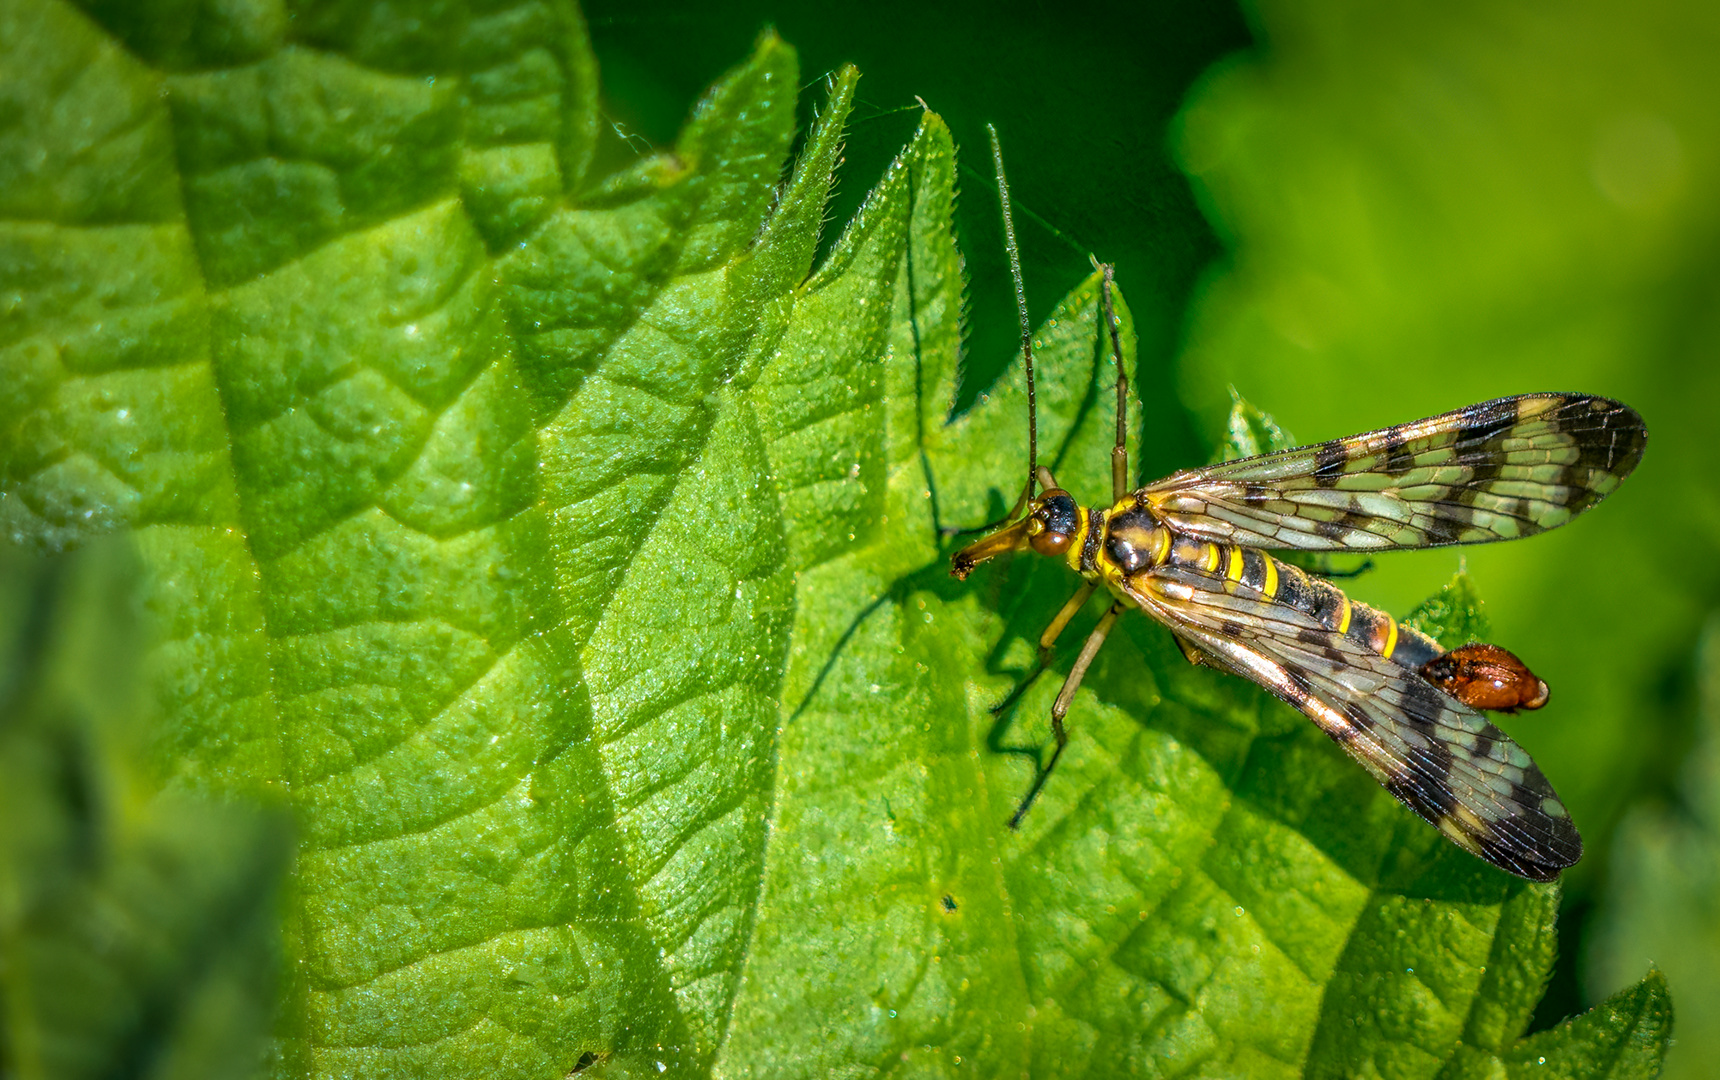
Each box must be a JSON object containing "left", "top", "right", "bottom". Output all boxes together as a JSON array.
[{"left": 951, "top": 394, "right": 1648, "bottom": 881}]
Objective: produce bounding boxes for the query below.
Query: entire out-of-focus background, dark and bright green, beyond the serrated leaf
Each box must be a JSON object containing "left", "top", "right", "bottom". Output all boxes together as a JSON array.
[{"left": 585, "top": 0, "right": 1720, "bottom": 1077}]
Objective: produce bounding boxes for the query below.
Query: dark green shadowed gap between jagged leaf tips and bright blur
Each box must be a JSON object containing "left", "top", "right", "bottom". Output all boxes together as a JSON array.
[{"left": 585, "top": 0, "right": 1250, "bottom": 475}]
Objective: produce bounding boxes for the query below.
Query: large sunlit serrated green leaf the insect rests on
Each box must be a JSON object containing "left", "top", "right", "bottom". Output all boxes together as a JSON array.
[{"left": 0, "top": 0, "right": 1668, "bottom": 1077}]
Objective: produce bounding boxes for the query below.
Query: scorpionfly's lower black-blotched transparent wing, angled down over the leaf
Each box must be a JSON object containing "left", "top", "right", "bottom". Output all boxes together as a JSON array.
[{"left": 1128, "top": 568, "right": 1582, "bottom": 881}]
